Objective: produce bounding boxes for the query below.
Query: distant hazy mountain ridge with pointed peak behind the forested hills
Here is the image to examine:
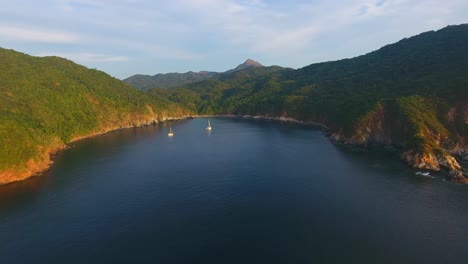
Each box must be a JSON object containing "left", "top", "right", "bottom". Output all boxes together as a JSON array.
[{"left": 123, "top": 59, "right": 263, "bottom": 91}]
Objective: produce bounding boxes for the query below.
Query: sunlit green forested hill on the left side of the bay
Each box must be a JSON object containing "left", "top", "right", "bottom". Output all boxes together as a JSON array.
[{"left": 0, "top": 49, "right": 189, "bottom": 184}]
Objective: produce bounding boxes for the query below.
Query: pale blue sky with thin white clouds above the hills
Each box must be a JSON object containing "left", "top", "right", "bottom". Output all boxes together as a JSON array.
[{"left": 0, "top": 0, "right": 468, "bottom": 79}]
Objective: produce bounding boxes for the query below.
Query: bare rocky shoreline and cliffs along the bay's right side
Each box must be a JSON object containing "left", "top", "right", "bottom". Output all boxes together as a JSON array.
[{"left": 221, "top": 105, "right": 468, "bottom": 183}]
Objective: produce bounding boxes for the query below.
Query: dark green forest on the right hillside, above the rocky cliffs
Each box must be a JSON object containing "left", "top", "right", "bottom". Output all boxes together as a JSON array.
[{"left": 151, "top": 25, "right": 468, "bottom": 135}]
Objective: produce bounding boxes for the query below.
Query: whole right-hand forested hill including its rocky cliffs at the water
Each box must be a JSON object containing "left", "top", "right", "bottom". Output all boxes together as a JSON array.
[{"left": 152, "top": 24, "right": 468, "bottom": 181}]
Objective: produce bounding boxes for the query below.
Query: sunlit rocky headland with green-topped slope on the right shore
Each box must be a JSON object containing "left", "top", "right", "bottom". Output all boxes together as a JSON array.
[{"left": 330, "top": 97, "right": 468, "bottom": 183}]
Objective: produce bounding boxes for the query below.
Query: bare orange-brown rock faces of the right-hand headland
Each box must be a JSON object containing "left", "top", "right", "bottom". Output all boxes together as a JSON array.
[{"left": 330, "top": 100, "right": 468, "bottom": 183}]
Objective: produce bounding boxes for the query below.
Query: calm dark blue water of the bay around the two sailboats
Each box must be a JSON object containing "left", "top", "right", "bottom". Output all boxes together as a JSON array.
[{"left": 0, "top": 119, "right": 468, "bottom": 264}]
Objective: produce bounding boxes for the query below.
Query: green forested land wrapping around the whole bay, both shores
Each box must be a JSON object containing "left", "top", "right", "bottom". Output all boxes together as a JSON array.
[{"left": 0, "top": 25, "right": 468, "bottom": 182}]
